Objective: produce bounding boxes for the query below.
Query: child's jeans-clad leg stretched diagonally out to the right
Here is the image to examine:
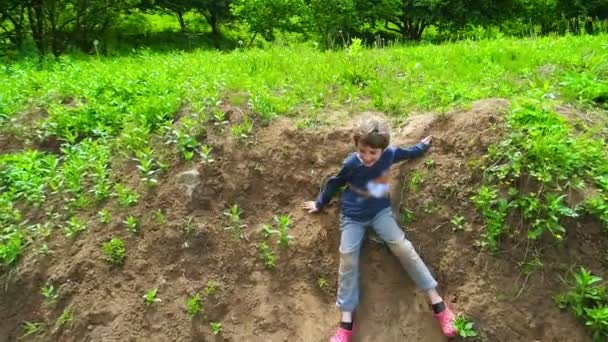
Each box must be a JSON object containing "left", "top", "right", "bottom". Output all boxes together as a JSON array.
[{"left": 372, "top": 208, "right": 441, "bottom": 292}]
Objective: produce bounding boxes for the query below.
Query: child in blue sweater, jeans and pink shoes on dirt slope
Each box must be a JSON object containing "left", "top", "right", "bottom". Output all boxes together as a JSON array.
[{"left": 302, "top": 117, "right": 456, "bottom": 342}]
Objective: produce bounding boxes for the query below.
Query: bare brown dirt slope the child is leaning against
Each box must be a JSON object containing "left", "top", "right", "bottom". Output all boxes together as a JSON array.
[{"left": 0, "top": 99, "right": 608, "bottom": 341}]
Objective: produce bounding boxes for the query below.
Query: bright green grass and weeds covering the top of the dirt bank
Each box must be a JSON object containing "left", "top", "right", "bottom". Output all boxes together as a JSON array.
[{"left": 0, "top": 34, "right": 608, "bottom": 270}]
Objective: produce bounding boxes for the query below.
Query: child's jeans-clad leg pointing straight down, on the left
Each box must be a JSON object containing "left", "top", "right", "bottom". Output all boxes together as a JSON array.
[{"left": 336, "top": 216, "right": 365, "bottom": 318}]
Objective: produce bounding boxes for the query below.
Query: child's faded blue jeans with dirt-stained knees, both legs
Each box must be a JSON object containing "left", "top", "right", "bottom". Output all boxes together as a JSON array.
[{"left": 336, "top": 208, "right": 437, "bottom": 312}]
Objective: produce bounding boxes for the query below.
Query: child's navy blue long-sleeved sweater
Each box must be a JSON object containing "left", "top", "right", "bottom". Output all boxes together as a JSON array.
[{"left": 316, "top": 143, "right": 429, "bottom": 222}]
